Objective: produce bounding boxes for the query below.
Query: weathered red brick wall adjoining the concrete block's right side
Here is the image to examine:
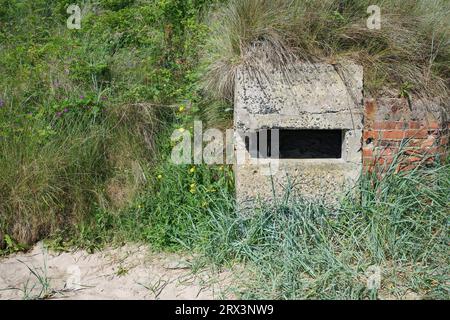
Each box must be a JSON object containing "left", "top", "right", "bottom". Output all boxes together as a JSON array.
[{"left": 362, "top": 99, "right": 449, "bottom": 170}]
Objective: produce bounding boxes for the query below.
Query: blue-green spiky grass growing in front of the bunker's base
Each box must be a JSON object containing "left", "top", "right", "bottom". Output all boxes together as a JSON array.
[{"left": 182, "top": 161, "right": 450, "bottom": 299}]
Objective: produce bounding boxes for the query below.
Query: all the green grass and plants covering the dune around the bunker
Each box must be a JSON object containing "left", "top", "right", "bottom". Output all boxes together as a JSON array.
[{"left": 0, "top": 0, "right": 450, "bottom": 299}]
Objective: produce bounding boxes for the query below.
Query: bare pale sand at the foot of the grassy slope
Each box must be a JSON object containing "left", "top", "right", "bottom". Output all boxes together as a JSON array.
[{"left": 0, "top": 243, "right": 233, "bottom": 299}]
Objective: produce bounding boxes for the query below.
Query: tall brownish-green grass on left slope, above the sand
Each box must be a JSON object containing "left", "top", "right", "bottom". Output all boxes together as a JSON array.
[{"left": 0, "top": 106, "right": 156, "bottom": 244}]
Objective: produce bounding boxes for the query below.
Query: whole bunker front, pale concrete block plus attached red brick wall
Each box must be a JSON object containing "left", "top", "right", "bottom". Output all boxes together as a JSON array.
[{"left": 234, "top": 62, "right": 449, "bottom": 204}]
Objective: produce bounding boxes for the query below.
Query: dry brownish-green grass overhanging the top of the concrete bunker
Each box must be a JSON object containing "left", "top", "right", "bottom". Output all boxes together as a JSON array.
[{"left": 203, "top": 0, "right": 450, "bottom": 101}]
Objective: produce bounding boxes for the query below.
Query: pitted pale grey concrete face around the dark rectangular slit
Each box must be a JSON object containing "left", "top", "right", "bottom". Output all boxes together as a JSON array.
[{"left": 234, "top": 63, "right": 363, "bottom": 204}]
